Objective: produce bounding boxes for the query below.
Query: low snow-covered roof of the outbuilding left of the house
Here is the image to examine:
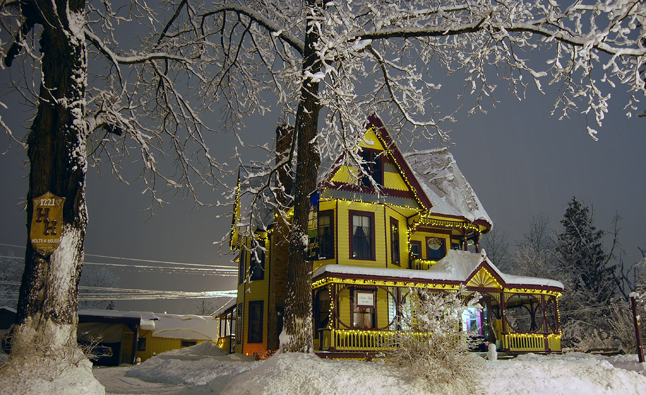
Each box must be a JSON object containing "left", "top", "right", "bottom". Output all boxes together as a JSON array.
[{"left": 79, "top": 310, "right": 220, "bottom": 341}]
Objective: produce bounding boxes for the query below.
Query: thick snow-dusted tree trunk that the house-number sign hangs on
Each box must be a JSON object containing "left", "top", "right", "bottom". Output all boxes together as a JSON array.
[{"left": 0, "top": 0, "right": 103, "bottom": 393}]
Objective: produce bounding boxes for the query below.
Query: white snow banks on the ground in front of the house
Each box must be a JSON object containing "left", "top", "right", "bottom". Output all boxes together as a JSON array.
[{"left": 94, "top": 342, "right": 646, "bottom": 395}]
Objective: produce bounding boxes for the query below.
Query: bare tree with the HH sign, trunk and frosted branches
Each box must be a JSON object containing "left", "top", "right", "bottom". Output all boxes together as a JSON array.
[{"left": 0, "top": 0, "right": 225, "bottom": 393}]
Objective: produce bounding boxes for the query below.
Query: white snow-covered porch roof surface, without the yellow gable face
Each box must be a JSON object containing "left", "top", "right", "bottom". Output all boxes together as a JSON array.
[{"left": 314, "top": 250, "right": 563, "bottom": 289}]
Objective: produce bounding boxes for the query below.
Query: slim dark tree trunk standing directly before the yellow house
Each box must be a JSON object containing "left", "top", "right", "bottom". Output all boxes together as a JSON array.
[{"left": 281, "top": 0, "right": 323, "bottom": 353}]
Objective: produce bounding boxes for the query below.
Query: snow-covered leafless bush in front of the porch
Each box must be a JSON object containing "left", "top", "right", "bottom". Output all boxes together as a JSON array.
[{"left": 389, "top": 286, "right": 484, "bottom": 394}]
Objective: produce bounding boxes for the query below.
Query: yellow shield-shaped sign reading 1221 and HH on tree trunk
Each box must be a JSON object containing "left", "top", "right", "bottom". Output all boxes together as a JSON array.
[{"left": 29, "top": 192, "right": 65, "bottom": 256}]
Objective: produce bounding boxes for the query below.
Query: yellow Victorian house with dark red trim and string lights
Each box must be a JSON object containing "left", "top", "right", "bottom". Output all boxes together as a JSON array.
[{"left": 221, "top": 116, "right": 563, "bottom": 357}]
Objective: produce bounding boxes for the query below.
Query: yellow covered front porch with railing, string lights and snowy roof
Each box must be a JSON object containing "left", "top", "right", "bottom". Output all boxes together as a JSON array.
[{"left": 313, "top": 251, "right": 562, "bottom": 355}]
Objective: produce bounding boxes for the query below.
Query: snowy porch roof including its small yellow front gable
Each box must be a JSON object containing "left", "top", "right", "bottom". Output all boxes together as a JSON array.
[{"left": 314, "top": 250, "right": 563, "bottom": 291}]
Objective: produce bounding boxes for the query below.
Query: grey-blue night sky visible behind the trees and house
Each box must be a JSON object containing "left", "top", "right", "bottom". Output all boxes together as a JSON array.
[{"left": 0, "top": 50, "right": 646, "bottom": 313}]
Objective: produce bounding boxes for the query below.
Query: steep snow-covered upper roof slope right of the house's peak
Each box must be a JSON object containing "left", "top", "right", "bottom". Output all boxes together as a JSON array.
[{"left": 404, "top": 148, "right": 493, "bottom": 226}]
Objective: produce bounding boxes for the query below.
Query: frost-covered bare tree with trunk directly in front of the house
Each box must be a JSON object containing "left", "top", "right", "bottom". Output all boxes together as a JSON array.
[{"left": 163, "top": 0, "right": 646, "bottom": 352}]
